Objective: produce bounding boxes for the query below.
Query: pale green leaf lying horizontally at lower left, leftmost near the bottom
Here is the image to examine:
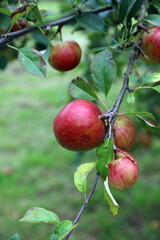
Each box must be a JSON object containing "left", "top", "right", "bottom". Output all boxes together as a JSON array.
[{"left": 20, "top": 207, "right": 60, "bottom": 225}]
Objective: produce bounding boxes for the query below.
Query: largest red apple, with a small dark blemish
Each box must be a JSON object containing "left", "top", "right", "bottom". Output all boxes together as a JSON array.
[{"left": 53, "top": 99, "right": 105, "bottom": 152}]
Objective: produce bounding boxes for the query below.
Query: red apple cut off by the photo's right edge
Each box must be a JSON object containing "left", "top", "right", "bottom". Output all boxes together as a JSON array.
[{"left": 141, "top": 27, "right": 160, "bottom": 64}]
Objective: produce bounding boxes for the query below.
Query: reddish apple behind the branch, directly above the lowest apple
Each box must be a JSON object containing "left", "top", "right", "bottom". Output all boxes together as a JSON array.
[{"left": 113, "top": 114, "right": 136, "bottom": 151}]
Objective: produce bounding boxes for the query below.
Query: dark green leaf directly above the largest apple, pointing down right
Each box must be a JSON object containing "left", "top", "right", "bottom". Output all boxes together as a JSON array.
[{"left": 68, "top": 77, "right": 98, "bottom": 101}]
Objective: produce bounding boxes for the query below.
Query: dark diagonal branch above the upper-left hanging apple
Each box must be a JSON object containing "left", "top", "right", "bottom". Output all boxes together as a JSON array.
[{"left": 0, "top": 6, "right": 112, "bottom": 45}]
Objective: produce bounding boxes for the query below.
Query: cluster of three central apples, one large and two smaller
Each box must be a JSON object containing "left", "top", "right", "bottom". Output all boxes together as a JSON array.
[{"left": 53, "top": 99, "right": 138, "bottom": 190}]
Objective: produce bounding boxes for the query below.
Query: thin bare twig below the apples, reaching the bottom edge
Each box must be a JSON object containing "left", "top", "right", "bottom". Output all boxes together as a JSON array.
[{"left": 65, "top": 173, "right": 100, "bottom": 240}]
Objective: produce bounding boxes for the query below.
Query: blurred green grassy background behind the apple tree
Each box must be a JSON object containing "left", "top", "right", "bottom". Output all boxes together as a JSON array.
[{"left": 0, "top": 1, "right": 160, "bottom": 240}]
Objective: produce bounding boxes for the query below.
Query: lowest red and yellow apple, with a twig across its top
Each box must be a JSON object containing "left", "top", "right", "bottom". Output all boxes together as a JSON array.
[{"left": 108, "top": 151, "right": 138, "bottom": 190}]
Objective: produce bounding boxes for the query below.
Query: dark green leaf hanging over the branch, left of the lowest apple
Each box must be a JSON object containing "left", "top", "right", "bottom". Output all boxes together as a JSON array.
[{"left": 96, "top": 138, "right": 114, "bottom": 179}]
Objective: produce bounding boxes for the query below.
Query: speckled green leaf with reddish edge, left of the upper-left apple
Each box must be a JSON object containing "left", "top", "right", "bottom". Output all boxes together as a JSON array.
[{"left": 18, "top": 47, "right": 47, "bottom": 77}]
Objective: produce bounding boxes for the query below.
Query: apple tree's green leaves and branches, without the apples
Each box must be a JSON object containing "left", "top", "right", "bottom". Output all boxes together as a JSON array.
[{"left": 0, "top": 0, "right": 160, "bottom": 240}]
